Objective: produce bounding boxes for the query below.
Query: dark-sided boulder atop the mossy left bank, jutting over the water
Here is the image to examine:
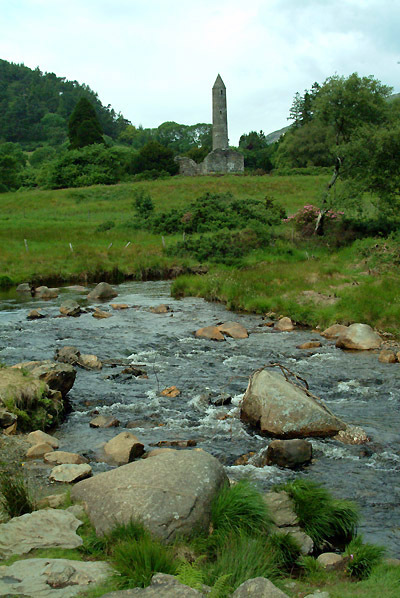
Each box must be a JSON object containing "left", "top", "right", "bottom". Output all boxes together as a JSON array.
[{"left": 12, "top": 359, "right": 76, "bottom": 397}]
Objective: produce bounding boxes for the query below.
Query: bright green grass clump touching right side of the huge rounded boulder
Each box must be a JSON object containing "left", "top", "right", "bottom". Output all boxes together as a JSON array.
[{"left": 211, "top": 480, "right": 272, "bottom": 534}]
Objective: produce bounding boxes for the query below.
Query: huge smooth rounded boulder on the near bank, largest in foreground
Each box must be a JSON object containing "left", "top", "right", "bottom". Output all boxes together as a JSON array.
[{"left": 71, "top": 450, "right": 228, "bottom": 541}]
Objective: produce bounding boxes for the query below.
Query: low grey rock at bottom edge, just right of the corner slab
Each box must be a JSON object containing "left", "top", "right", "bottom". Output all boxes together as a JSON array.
[{"left": 101, "top": 573, "right": 205, "bottom": 598}]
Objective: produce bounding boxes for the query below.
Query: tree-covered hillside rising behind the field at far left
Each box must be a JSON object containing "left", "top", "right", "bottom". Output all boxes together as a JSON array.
[{"left": 0, "top": 60, "right": 129, "bottom": 149}]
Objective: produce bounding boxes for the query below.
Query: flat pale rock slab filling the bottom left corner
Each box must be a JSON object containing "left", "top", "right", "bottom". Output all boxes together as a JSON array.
[{"left": 0, "top": 559, "right": 112, "bottom": 598}]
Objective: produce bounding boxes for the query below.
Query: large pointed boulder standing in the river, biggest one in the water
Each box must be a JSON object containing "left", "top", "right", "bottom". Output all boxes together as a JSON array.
[{"left": 240, "top": 369, "right": 346, "bottom": 438}]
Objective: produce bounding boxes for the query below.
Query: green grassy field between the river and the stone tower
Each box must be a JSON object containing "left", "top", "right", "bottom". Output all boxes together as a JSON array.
[{"left": 0, "top": 175, "right": 400, "bottom": 334}]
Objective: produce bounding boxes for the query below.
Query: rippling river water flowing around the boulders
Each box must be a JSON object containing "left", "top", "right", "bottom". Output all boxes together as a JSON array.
[{"left": 0, "top": 282, "right": 400, "bottom": 557}]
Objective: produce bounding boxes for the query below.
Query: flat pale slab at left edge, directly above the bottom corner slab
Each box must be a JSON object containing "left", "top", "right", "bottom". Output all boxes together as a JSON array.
[{"left": 0, "top": 509, "right": 82, "bottom": 560}]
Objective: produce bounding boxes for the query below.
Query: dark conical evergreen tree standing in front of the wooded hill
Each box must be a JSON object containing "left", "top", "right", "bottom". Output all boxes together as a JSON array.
[{"left": 68, "top": 98, "right": 103, "bottom": 149}]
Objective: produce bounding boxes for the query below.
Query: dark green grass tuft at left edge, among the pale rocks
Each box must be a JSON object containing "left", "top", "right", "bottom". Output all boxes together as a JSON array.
[{"left": 0, "top": 471, "right": 35, "bottom": 517}]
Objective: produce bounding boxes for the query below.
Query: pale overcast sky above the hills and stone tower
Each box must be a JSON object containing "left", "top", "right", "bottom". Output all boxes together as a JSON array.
[{"left": 0, "top": 0, "right": 400, "bottom": 145}]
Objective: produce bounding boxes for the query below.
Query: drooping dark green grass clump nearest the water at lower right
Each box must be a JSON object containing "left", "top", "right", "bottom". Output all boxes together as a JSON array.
[{"left": 279, "top": 479, "right": 360, "bottom": 549}]
